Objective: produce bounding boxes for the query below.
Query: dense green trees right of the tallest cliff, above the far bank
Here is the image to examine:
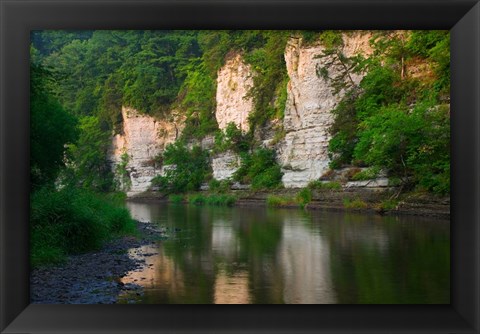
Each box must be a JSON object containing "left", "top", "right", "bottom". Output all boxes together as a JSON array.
[{"left": 326, "top": 31, "right": 450, "bottom": 194}]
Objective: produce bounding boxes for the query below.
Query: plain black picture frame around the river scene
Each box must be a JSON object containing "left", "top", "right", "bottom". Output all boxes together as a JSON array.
[{"left": 0, "top": 0, "right": 480, "bottom": 333}]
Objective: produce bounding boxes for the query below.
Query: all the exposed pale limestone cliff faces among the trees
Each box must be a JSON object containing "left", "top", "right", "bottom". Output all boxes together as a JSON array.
[{"left": 108, "top": 32, "right": 372, "bottom": 195}]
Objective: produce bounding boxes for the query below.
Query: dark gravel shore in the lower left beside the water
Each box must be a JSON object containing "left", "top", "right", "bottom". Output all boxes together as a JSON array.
[{"left": 30, "top": 221, "right": 166, "bottom": 304}]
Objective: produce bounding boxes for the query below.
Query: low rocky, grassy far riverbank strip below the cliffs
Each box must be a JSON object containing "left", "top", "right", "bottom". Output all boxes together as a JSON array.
[{"left": 129, "top": 188, "right": 450, "bottom": 219}]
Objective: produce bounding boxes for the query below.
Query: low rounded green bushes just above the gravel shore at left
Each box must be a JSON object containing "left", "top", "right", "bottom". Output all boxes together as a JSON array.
[{"left": 30, "top": 187, "right": 135, "bottom": 267}]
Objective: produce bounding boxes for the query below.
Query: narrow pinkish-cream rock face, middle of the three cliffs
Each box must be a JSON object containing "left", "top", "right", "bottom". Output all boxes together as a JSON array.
[{"left": 215, "top": 55, "right": 253, "bottom": 132}]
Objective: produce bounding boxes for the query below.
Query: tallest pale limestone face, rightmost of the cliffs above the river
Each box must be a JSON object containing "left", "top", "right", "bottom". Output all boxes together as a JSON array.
[{"left": 278, "top": 32, "right": 371, "bottom": 188}]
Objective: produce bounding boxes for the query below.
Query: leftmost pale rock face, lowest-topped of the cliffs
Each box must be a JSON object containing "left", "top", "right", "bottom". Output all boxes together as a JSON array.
[{"left": 109, "top": 107, "right": 182, "bottom": 196}]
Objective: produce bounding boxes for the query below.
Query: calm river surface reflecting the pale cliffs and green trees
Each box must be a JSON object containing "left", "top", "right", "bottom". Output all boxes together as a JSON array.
[{"left": 122, "top": 202, "right": 450, "bottom": 304}]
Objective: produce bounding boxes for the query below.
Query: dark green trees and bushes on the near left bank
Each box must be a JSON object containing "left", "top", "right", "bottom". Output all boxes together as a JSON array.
[{"left": 30, "top": 64, "right": 134, "bottom": 266}]
